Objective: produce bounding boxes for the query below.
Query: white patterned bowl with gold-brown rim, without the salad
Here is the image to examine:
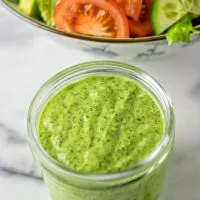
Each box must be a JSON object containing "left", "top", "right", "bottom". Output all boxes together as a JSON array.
[{"left": 0, "top": 0, "right": 200, "bottom": 60}]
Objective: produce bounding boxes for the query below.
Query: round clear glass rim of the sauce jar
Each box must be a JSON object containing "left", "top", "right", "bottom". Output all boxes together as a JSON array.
[{"left": 27, "top": 61, "right": 175, "bottom": 181}]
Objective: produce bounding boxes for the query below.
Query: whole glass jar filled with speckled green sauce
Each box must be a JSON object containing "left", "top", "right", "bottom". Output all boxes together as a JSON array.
[{"left": 28, "top": 61, "right": 174, "bottom": 200}]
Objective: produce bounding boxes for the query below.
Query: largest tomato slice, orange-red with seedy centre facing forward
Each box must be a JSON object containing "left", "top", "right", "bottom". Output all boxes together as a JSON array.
[{"left": 54, "top": 0, "right": 129, "bottom": 38}]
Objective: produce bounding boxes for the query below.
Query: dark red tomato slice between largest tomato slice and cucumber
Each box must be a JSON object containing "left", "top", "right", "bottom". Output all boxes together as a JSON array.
[{"left": 129, "top": 0, "right": 153, "bottom": 37}]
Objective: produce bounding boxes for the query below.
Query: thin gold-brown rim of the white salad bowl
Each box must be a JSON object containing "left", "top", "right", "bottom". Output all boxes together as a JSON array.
[{"left": 0, "top": 0, "right": 200, "bottom": 44}]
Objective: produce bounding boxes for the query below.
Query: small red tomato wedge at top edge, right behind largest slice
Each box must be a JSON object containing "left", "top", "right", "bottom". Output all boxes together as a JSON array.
[{"left": 116, "top": 0, "right": 144, "bottom": 21}]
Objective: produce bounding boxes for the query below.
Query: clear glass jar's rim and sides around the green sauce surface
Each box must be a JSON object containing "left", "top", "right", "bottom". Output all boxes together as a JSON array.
[{"left": 28, "top": 61, "right": 175, "bottom": 200}]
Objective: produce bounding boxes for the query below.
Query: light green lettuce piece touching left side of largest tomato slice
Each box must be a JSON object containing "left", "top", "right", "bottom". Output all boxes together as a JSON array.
[{"left": 37, "top": 0, "right": 58, "bottom": 25}]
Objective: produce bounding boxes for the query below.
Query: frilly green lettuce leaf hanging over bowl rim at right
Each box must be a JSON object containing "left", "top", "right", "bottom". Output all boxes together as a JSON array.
[{"left": 166, "top": 15, "right": 200, "bottom": 45}]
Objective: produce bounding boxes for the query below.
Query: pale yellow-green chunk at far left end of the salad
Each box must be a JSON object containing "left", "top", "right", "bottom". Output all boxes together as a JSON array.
[{"left": 19, "top": 0, "right": 39, "bottom": 17}]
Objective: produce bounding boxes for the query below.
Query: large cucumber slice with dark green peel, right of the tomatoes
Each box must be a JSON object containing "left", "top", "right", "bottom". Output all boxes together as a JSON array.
[{"left": 152, "top": 0, "right": 187, "bottom": 35}]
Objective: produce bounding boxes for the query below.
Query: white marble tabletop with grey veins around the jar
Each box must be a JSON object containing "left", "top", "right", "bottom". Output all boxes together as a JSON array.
[{"left": 0, "top": 5, "right": 200, "bottom": 200}]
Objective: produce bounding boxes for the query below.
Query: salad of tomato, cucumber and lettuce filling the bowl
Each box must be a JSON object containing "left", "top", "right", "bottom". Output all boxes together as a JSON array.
[{"left": 18, "top": 0, "right": 200, "bottom": 44}]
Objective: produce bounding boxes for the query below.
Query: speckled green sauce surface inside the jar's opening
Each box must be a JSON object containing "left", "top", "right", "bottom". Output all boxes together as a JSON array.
[{"left": 38, "top": 76, "right": 164, "bottom": 173}]
